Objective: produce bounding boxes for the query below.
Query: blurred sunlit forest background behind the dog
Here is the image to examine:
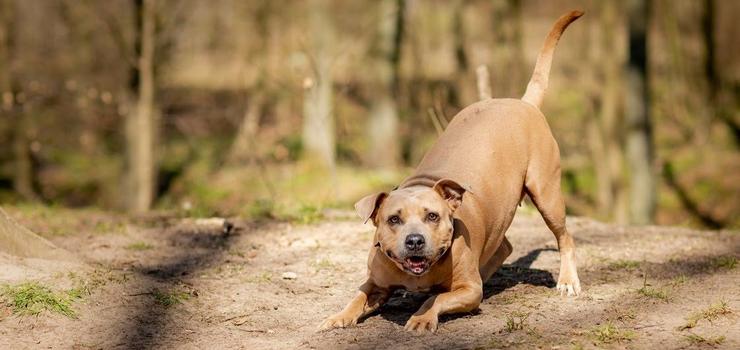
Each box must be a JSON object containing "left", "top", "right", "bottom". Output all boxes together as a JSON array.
[{"left": 0, "top": 0, "right": 740, "bottom": 228}]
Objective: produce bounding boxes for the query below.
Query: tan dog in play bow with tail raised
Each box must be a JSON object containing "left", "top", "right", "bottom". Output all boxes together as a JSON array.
[{"left": 318, "top": 11, "right": 583, "bottom": 332}]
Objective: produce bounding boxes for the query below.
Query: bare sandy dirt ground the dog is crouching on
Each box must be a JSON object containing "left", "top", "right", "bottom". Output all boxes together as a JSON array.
[{"left": 0, "top": 207, "right": 740, "bottom": 349}]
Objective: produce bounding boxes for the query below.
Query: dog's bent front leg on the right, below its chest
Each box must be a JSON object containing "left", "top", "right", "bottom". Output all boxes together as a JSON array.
[{"left": 404, "top": 283, "right": 483, "bottom": 332}]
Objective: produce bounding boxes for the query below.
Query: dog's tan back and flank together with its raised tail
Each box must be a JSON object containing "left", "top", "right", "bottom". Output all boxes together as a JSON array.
[{"left": 399, "top": 11, "right": 583, "bottom": 260}]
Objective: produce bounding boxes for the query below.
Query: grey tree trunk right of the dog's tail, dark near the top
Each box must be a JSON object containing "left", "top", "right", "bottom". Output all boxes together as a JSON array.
[{"left": 626, "top": 0, "right": 655, "bottom": 225}]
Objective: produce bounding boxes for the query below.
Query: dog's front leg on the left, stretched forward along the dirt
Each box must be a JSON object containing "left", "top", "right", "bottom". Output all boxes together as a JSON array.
[{"left": 316, "top": 279, "right": 391, "bottom": 332}]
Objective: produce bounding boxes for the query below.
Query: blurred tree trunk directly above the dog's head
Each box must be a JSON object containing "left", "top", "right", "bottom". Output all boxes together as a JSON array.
[{"left": 367, "top": 0, "right": 404, "bottom": 169}]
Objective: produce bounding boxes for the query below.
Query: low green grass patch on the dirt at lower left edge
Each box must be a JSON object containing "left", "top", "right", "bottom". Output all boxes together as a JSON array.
[{"left": 0, "top": 282, "right": 77, "bottom": 318}]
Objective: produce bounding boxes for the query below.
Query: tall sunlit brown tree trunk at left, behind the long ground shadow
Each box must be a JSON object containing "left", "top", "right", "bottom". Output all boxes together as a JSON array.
[{"left": 126, "top": 0, "right": 156, "bottom": 212}]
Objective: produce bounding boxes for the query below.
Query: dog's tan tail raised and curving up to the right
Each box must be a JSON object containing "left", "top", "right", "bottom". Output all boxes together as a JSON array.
[{"left": 522, "top": 11, "right": 583, "bottom": 109}]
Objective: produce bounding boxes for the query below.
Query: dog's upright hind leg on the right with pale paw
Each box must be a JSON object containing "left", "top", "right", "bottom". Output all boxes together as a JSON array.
[{"left": 525, "top": 150, "right": 581, "bottom": 295}]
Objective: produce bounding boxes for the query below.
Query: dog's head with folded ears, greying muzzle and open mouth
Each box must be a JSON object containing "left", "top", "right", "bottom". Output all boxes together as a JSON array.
[{"left": 355, "top": 180, "right": 470, "bottom": 276}]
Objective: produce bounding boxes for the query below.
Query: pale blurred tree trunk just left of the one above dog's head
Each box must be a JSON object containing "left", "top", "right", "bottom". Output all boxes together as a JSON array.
[{"left": 303, "top": 0, "right": 336, "bottom": 169}]
